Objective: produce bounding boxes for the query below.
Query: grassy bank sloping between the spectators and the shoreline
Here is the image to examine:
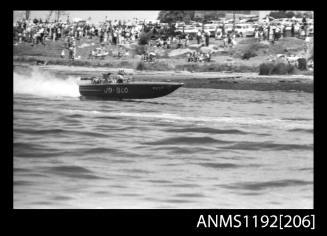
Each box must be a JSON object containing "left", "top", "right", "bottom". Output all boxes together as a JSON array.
[{"left": 14, "top": 38, "right": 312, "bottom": 74}]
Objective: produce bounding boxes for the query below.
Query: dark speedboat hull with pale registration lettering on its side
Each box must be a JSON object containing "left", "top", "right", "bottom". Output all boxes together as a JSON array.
[{"left": 79, "top": 82, "right": 183, "bottom": 100}]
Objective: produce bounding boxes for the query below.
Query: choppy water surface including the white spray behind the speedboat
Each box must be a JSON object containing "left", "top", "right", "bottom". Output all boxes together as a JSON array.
[{"left": 13, "top": 69, "right": 313, "bottom": 208}]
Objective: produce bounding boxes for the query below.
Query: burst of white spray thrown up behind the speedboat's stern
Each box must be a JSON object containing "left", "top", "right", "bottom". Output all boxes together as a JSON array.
[{"left": 14, "top": 69, "right": 80, "bottom": 97}]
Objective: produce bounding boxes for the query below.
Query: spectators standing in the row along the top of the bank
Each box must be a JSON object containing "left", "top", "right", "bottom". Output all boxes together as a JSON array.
[{"left": 13, "top": 14, "right": 316, "bottom": 48}]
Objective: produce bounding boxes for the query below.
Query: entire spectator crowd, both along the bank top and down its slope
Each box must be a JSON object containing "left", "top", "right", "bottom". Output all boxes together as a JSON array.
[{"left": 13, "top": 14, "right": 309, "bottom": 61}]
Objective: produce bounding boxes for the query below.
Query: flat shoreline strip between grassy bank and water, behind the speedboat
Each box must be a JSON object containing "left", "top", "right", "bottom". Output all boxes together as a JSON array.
[{"left": 14, "top": 61, "right": 313, "bottom": 93}]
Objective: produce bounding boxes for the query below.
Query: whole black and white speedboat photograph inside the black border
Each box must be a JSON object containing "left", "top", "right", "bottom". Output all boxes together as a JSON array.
[{"left": 10, "top": 9, "right": 314, "bottom": 209}]
